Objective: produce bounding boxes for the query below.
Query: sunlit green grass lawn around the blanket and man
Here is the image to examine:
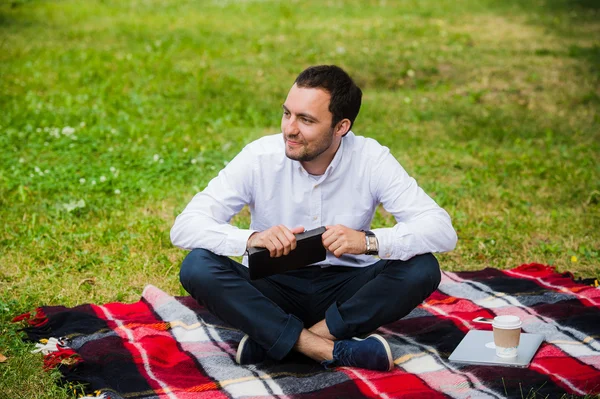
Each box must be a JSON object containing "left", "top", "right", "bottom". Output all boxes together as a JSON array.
[{"left": 0, "top": 0, "right": 600, "bottom": 398}]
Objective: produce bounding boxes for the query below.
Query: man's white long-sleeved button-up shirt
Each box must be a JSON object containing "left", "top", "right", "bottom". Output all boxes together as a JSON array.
[{"left": 171, "top": 132, "right": 457, "bottom": 267}]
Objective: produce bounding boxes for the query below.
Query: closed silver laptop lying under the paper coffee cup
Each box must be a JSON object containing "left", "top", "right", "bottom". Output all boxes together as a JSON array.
[{"left": 448, "top": 330, "right": 544, "bottom": 367}]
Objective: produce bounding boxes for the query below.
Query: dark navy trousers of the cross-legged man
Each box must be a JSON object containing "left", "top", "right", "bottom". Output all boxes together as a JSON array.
[{"left": 179, "top": 249, "right": 441, "bottom": 360}]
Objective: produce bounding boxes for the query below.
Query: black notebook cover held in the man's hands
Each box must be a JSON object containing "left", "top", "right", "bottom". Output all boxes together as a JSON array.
[{"left": 248, "top": 227, "right": 326, "bottom": 280}]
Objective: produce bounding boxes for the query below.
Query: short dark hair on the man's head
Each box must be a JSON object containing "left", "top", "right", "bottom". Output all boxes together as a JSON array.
[{"left": 294, "top": 65, "right": 362, "bottom": 128}]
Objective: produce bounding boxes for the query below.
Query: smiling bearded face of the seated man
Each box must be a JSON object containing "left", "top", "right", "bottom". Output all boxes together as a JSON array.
[{"left": 281, "top": 84, "right": 334, "bottom": 162}]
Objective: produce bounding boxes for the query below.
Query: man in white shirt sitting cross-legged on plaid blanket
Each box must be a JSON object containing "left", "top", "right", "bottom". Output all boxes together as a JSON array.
[{"left": 171, "top": 65, "right": 457, "bottom": 371}]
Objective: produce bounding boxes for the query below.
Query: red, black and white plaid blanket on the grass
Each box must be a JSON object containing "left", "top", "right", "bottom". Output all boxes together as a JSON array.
[{"left": 15, "top": 264, "right": 600, "bottom": 399}]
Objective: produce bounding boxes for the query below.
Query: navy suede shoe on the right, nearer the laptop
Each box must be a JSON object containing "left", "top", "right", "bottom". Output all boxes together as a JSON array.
[{"left": 321, "top": 334, "right": 394, "bottom": 371}]
